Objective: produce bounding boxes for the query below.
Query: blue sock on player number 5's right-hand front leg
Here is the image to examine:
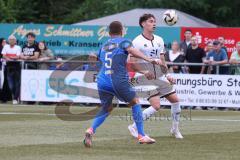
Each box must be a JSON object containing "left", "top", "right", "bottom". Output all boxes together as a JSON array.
[{"left": 132, "top": 104, "right": 145, "bottom": 136}]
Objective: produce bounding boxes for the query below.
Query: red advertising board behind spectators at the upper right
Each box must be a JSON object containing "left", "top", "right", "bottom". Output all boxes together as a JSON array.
[{"left": 181, "top": 27, "right": 240, "bottom": 56}]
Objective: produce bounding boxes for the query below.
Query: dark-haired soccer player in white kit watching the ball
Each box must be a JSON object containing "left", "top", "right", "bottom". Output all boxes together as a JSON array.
[{"left": 128, "top": 14, "right": 183, "bottom": 139}]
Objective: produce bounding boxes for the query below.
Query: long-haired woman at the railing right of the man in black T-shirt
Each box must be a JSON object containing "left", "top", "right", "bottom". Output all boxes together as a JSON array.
[{"left": 38, "top": 42, "right": 54, "bottom": 69}]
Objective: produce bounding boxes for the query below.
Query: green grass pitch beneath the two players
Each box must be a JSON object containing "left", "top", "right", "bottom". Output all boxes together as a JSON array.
[{"left": 0, "top": 105, "right": 240, "bottom": 160}]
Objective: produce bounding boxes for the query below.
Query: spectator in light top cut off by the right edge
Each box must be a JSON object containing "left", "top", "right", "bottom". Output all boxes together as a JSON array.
[{"left": 229, "top": 41, "right": 240, "bottom": 75}]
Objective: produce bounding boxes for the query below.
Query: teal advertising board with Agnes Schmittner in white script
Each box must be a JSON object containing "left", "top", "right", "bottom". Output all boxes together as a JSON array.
[{"left": 0, "top": 24, "right": 180, "bottom": 56}]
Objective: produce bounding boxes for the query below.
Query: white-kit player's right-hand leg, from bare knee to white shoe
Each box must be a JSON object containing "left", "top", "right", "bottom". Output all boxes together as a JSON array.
[{"left": 165, "top": 93, "right": 183, "bottom": 139}]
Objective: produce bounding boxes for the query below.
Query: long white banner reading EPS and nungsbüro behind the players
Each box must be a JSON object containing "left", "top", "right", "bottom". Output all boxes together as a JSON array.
[{"left": 21, "top": 70, "right": 240, "bottom": 107}]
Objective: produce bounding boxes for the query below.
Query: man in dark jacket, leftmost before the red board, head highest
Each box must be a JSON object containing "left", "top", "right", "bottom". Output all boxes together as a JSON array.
[{"left": 180, "top": 29, "right": 192, "bottom": 55}]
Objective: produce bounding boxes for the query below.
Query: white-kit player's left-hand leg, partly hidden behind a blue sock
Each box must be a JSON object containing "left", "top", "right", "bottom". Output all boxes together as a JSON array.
[{"left": 128, "top": 95, "right": 160, "bottom": 137}]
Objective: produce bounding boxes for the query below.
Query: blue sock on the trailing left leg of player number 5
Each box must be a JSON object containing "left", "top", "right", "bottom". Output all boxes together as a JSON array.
[{"left": 92, "top": 107, "right": 109, "bottom": 133}]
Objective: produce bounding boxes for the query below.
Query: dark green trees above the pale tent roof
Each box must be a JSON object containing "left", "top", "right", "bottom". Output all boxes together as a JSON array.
[{"left": 0, "top": 0, "right": 240, "bottom": 27}]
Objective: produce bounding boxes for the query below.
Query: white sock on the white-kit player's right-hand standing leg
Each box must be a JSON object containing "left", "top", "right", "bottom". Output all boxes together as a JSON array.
[{"left": 171, "top": 102, "right": 181, "bottom": 129}]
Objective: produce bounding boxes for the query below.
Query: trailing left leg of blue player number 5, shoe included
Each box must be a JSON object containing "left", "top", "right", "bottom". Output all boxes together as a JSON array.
[{"left": 83, "top": 90, "right": 114, "bottom": 147}]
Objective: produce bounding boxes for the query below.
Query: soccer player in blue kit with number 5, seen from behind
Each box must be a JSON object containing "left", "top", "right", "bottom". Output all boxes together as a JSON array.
[{"left": 84, "top": 21, "right": 158, "bottom": 147}]
